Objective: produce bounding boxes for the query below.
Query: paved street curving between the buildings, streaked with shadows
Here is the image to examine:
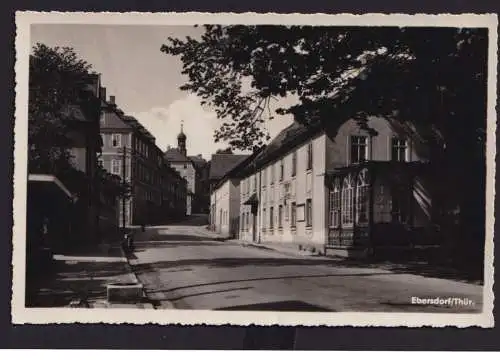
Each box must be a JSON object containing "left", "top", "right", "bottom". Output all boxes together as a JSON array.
[{"left": 130, "top": 217, "right": 482, "bottom": 312}]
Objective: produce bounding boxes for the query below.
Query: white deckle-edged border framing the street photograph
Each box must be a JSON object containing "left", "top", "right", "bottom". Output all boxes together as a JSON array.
[{"left": 11, "top": 11, "right": 498, "bottom": 327}]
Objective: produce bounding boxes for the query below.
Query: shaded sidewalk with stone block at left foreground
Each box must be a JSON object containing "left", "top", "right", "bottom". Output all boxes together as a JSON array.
[{"left": 26, "top": 239, "right": 152, "bottom": 308}]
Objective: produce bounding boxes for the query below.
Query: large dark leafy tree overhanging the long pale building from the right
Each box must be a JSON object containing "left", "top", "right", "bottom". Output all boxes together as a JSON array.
[{"left": 161, "top": 25, "right": 488, "bottom": 270}]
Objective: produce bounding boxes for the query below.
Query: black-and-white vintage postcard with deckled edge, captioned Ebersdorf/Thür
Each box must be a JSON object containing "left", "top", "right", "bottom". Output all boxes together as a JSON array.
[{"left": 12, "top": 12, "right": 498, "bottom": 327}]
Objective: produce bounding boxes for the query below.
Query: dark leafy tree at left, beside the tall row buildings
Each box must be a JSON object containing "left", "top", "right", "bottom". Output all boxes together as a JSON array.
[{"left": 28, "top": 43, "right": 91, "bottom": 174}]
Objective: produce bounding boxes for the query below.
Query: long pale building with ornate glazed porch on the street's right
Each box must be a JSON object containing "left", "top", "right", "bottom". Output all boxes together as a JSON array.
[{"left": 240, "top": 117, "right": 432, "bottom": 255}]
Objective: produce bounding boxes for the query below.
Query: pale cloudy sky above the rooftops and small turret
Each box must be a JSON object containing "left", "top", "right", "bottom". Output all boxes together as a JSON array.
[{"left": 31, "top": 24, "right": 291, "bottom": 160}]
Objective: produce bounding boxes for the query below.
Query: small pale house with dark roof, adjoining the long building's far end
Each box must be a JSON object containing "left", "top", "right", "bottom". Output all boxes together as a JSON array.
[{"left": 208, "top": 154, "right": 248, "bottom": 231}]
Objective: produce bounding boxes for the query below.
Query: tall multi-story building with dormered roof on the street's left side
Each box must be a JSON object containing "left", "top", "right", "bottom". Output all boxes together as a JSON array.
[{"left": 99, "top": 96, "right": 183, "bottom": 226}]
